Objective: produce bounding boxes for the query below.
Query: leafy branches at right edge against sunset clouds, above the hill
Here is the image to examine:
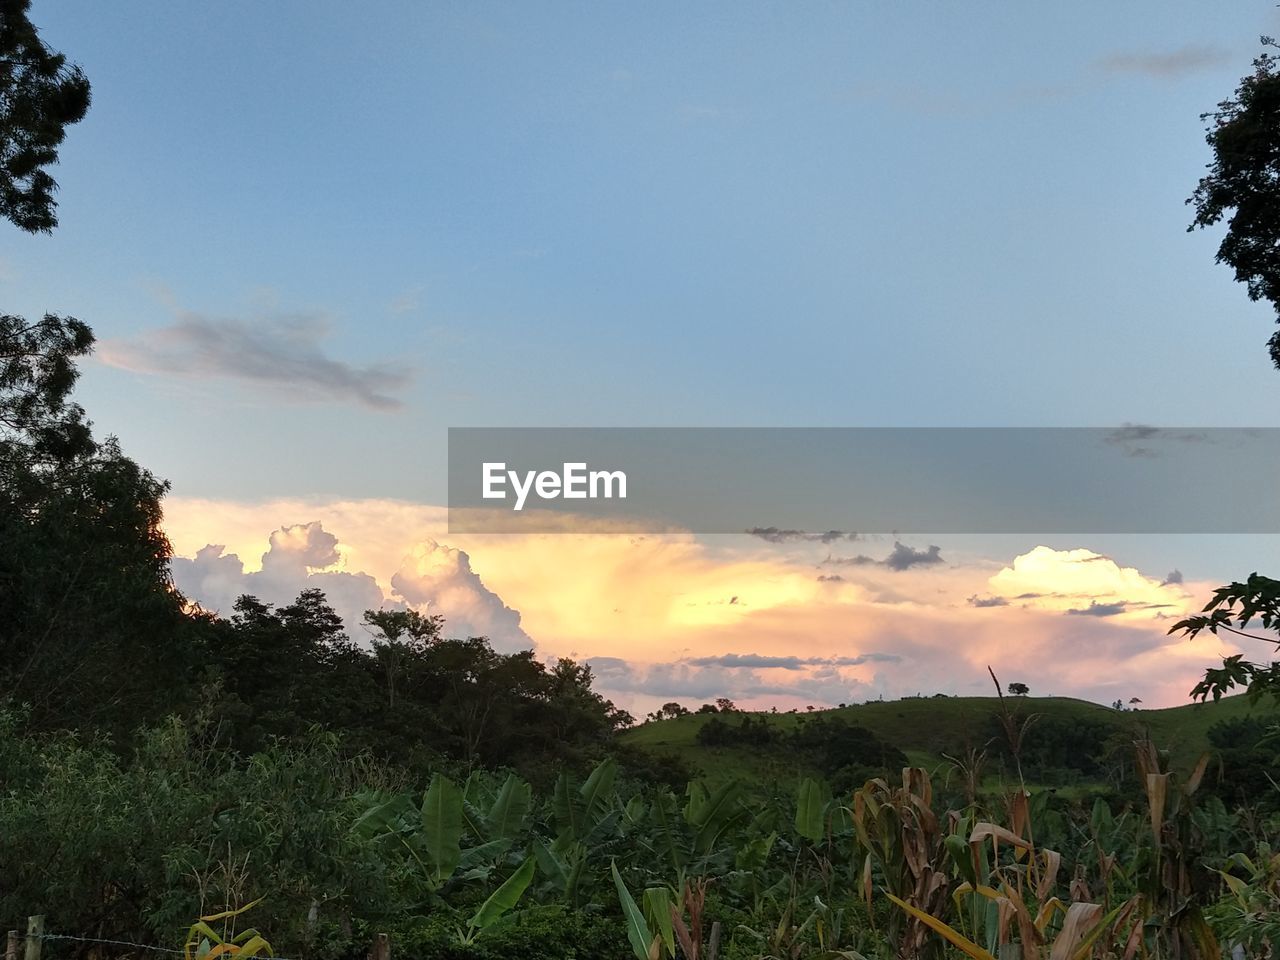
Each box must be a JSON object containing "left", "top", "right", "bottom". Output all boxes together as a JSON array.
[{"left": 1169, "top": 573, "right": 1280, "bottom": 700}]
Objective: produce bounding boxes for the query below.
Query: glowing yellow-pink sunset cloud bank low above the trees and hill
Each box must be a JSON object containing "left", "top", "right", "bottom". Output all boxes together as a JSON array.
[{"left": 166, "top": 498, "right": 1234, "bottom": 713}]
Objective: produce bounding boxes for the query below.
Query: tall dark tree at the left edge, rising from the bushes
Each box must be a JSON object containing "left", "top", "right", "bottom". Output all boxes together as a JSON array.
[{"left": 0, "top": 315, "right": 192, "bottom": 733}]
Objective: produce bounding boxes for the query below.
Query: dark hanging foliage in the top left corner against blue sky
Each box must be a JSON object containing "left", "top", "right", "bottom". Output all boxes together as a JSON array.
[{"left": 0, "top": 0, "right": 90, "bottom": 233}]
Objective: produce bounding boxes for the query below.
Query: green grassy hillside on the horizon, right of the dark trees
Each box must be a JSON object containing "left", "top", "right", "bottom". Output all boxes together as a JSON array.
[{"left": 625, "top": 696, "right": 1280, "bottom": 782}]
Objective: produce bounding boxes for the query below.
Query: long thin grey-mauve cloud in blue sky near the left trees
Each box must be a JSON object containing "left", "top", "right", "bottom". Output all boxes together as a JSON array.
[{"left": 97, "top": 310, "right": 412, "bottom": 410}]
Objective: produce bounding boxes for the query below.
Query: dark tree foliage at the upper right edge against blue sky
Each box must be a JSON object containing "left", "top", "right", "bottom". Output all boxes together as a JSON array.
[{"left": 1187, "top": 37, "right": 1280, "bottom": 369}]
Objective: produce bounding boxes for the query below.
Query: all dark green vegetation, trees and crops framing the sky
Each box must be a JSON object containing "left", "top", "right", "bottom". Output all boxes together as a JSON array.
[{"left": 0, "top": 7, "right": 1280, "bottom": 960}]
